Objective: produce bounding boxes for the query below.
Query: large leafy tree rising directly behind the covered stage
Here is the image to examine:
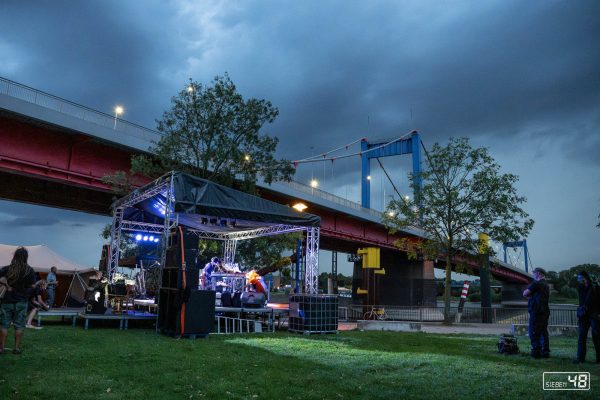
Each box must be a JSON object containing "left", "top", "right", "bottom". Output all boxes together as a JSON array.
[{"left": 104, "top": 74, "right": 294, "bottom": 268}]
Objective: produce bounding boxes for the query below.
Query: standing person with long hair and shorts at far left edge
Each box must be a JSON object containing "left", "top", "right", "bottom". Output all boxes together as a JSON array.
[{"left": 0, "top": 247, "right": 35, "bottom": 354}]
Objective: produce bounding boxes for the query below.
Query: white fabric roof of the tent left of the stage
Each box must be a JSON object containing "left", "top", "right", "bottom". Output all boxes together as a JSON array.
[{"left": 0, "top": 244, "right": 93, "bottom": 274}]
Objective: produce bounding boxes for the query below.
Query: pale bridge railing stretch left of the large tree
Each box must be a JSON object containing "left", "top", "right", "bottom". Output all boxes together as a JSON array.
[{"left": 0, "top": 77, "right": 162, "bottom": 147}]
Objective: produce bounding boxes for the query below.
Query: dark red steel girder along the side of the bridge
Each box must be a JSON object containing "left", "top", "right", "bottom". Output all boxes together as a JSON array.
[{"left": 0, "top": 112, "right": 528, "bottom": 283}]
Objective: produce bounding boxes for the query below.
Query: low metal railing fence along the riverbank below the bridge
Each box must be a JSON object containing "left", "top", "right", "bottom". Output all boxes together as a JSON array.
[{"left": 339, "top": 305, "right": 577, "bottom": 325}]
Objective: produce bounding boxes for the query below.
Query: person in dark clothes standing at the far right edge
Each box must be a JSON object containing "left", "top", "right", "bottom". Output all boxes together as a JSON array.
[{"left": 573, "top": 271, "right": 600, "bottom": 364}]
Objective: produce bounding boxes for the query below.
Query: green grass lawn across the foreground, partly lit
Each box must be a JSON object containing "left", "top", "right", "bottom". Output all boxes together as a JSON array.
[{"left": 0, "top": 324, "right": 600, "bottom": 400}]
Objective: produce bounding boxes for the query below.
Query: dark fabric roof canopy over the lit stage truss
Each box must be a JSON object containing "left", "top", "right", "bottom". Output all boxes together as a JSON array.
[{"left": 114, "top": 171, "right": 321, "bottom": 239}]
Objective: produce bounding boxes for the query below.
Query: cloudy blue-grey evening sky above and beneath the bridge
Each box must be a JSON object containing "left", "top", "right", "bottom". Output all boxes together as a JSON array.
[{"left": 0, "top": 0, "right": 600, "bottom": 276}]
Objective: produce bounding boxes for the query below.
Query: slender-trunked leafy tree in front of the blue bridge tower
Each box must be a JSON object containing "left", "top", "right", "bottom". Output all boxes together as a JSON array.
[{"left": 384, "top": 138, "right": 533, "bottom": 322}]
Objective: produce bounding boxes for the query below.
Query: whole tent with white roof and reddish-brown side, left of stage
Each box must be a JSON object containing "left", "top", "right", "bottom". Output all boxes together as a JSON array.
[{"left": 0, "top": 244, "right": 95, "bottom": 305}]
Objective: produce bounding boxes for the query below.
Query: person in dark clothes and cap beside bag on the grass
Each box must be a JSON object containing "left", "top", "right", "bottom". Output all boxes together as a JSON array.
[{"left": 523, "top": 267, "right": 550, "bottom": 358}]
